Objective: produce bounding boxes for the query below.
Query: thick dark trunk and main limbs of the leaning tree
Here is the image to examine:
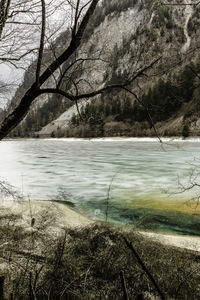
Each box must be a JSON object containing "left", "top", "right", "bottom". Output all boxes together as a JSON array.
[{"left": 0, "top": 0, "right": 161, "bottom": 139}]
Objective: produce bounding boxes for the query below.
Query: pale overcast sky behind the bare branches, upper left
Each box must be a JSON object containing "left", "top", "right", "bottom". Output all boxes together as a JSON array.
[{"left": 0, "top": 0, "right": 78, "bottom": 107}]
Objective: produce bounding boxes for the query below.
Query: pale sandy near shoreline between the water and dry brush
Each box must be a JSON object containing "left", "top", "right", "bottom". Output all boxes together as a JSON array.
[{"left": 0, "top": 200, "right": 200, "bottom": 252}]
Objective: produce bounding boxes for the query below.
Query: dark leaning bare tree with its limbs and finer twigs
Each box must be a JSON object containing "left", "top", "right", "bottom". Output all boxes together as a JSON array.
[{"left": 0, "top": 0, "right": 160, "bottom": 139}]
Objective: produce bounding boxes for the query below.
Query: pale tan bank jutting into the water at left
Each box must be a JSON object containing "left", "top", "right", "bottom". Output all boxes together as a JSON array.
[{"left": 0, "top": 200, "right": 92, "bottom": 231}]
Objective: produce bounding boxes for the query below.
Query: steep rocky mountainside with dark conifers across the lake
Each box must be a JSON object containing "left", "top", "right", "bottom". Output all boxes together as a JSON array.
[{"left": 7, "top": 0, "right": 200, "bottom": 137}]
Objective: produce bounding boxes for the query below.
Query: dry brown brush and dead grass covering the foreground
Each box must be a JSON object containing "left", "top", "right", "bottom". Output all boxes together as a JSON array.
[{"left": 0, "top": 215, "right": 200, "bottom": 300}]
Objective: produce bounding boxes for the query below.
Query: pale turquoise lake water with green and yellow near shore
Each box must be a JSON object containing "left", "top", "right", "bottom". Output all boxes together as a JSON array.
[{"left": 0, "top": 139, "right": 200, "bottom": 235}]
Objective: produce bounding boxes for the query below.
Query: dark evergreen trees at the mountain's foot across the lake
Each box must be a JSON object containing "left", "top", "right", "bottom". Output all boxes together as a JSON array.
[{"left": 62, "top": 63, "right": 200, "bottom": 137}]
